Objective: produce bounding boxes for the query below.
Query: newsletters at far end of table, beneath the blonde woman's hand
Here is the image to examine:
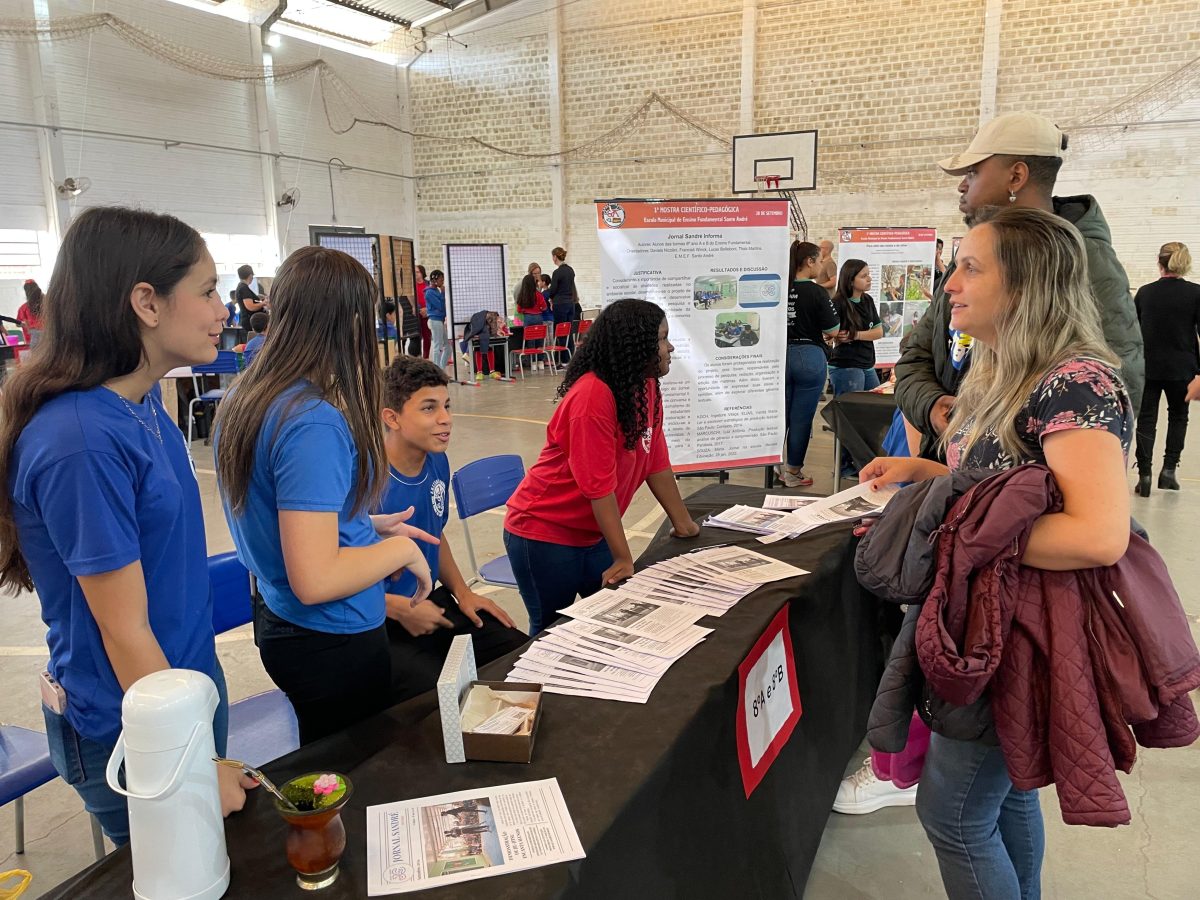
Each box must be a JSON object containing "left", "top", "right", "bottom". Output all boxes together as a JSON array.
[{"left": 704, "top": 484, "right": 899, "bottom": 544}]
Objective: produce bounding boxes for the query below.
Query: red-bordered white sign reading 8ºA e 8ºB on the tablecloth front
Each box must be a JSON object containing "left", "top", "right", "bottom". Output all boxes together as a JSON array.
[{"left": 737, "top": 604, "right": 803, "bottom": 797}]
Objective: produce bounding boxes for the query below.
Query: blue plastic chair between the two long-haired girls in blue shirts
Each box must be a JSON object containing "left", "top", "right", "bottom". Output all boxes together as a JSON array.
[{"left": 209, "top": 552, "right": 300, "bottom": 768}]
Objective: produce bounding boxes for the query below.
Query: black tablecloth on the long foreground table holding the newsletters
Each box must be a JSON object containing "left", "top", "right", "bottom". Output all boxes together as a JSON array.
[{"left": 53, "top": 485, "right": 882, "bottom": 900}]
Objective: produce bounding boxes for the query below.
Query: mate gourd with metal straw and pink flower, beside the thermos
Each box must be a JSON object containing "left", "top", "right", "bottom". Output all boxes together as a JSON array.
[{"left": 275, "top": 772, "right": 353, "bottom": 890}]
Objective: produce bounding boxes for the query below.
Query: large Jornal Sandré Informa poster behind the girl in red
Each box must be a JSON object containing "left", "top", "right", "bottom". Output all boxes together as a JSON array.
[{"left": 596, "top": 199, "right": 790, "bottom": 472}]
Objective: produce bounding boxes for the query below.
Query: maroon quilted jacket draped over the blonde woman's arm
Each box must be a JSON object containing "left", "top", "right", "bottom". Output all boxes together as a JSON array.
[{"left": 917, "top": 464, "right": 1200, "bottom": 826}]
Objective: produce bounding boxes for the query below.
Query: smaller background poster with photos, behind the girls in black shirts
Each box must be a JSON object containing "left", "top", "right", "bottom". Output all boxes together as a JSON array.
[{"left": 838, "top": 228, "right": 937, "bottom": 365}]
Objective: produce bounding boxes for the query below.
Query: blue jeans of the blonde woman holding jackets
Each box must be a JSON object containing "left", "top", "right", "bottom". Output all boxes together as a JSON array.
[{"left": 917, "top": 734, "right": 1045, "bottom": 900}]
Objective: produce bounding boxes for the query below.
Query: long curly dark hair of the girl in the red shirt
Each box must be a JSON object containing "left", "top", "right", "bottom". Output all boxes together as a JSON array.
[{"left": 558, "top": 300, "right": 666, "bottom": 450}]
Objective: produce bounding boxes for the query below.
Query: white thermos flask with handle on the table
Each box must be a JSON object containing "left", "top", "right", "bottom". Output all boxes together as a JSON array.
[{"left": 108, "top": 668, "right": 229, "bottom": 900}]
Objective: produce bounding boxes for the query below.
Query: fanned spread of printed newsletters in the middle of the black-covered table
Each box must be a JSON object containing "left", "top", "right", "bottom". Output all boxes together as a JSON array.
[{"left": 508, "top": 546, "right": 808, "bottom": 703}]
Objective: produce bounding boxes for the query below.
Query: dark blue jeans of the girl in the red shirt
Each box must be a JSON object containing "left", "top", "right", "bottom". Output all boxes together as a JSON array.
[{"left": 504, "top": 529, "right": 612, "bottom": 637}]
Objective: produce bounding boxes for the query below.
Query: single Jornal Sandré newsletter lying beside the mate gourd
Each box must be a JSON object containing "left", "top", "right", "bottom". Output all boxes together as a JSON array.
[{"left": 367, "top": 778, "right": 586, "bottom": 896}]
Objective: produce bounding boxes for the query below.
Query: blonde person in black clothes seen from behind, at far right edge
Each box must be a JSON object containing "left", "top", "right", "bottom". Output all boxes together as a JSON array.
[{"left": 1133, "top": 241, "right": 1200, "bottom": 497}]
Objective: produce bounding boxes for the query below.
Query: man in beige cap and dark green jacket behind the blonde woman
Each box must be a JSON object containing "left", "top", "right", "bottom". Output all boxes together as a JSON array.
[{"left": 895, "top": 113, "right": 1145, "bottom": 458}]
